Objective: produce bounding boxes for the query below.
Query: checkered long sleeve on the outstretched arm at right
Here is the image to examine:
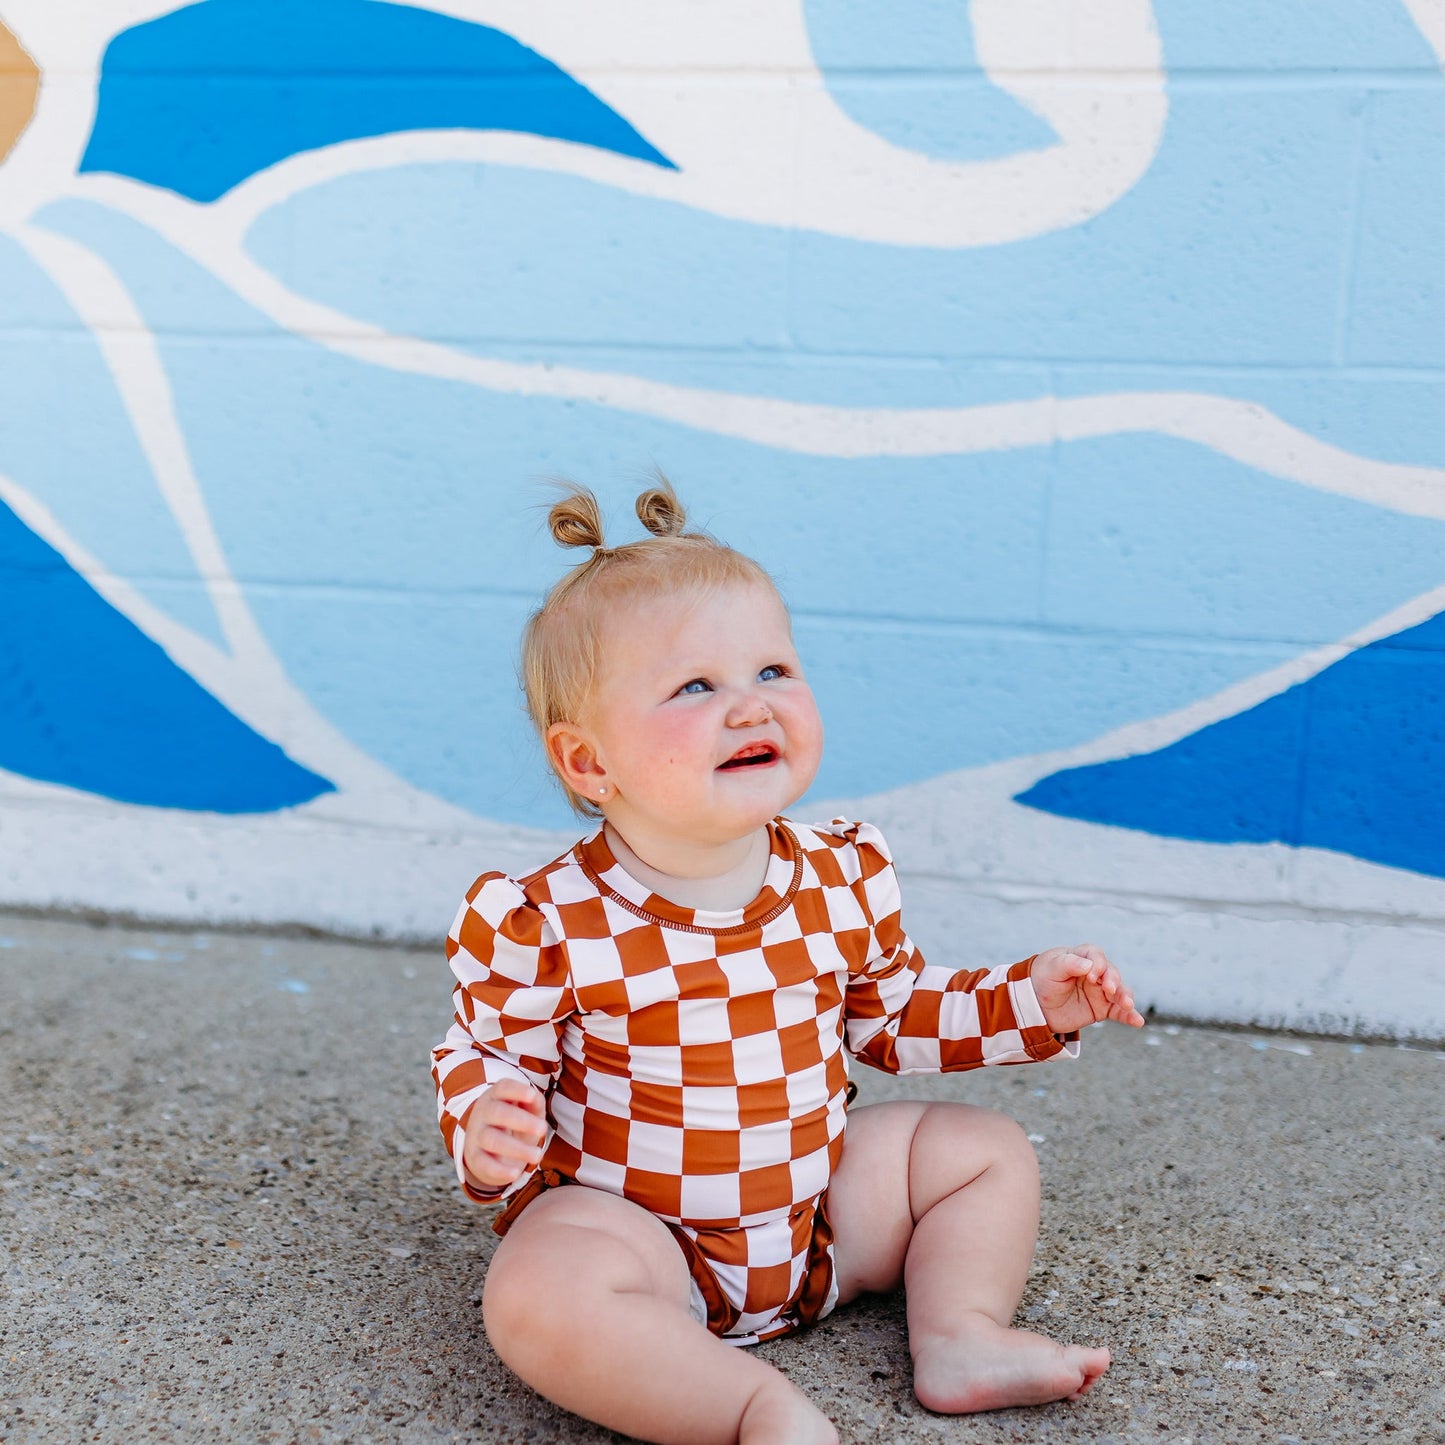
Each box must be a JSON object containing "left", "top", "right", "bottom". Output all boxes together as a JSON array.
[{"left": 844, "top": 824, "right": 1078, "bottom": 1074}]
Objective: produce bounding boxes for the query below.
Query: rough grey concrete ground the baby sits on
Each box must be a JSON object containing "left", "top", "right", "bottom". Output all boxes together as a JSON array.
[{"left": 0, "top": 918, "right": 1445, "bottom": 1445}]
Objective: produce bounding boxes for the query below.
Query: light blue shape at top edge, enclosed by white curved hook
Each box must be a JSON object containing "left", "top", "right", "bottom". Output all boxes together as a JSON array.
[{"left": 803, "top": 0, "right": 1059, "bottom": 160}]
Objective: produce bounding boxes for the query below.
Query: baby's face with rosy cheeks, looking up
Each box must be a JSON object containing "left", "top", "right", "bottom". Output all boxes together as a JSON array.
[{"left": 585, "top": 584, "right": 822, "bottom": 849}]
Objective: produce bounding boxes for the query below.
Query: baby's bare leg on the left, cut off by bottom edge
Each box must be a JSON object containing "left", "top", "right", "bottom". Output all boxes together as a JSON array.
[{"left": 483, "top": 1185, "right": 838, "bottom": 1445}]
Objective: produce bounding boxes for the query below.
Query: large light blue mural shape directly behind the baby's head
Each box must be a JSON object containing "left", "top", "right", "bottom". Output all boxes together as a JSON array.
[{"left": 36, "top": 205, "right": 1445, "bottom": 825}]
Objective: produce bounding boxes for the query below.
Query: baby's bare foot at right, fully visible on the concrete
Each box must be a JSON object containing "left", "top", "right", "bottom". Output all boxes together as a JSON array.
[{"left": 913, "top": 1314, "right": 1108, "bottom": 1415}]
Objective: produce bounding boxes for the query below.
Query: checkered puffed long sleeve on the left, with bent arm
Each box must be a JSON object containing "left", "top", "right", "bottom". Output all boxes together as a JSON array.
[{"left": 432, "top": 873, "right": 575, "bottom": 1201}]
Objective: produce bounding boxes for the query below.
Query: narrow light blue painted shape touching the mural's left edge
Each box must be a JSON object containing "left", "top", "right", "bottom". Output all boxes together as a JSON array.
[{"left": 0, "top": 234, "right": 223, "bottom": 643}]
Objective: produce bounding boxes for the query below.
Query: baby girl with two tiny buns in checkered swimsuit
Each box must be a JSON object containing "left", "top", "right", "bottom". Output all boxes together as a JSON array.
[{"left": 434, "top": 483, "right": 1143, "bottom": 1445}]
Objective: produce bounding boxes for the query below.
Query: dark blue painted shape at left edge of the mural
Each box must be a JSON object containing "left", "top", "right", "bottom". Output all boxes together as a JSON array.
[{"left": 0, "top": 503, "right": 335, "bottom": 814}]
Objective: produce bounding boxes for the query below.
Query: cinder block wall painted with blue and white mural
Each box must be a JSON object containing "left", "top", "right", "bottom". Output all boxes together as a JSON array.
[{"left": 0, "top": 0, "right": 1445, "bottom": 1038}]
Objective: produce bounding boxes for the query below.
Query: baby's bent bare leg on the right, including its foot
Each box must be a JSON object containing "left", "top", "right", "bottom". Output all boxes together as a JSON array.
[{"left": 828, "top": 1104, "right": 1108, "bottom": 1415}]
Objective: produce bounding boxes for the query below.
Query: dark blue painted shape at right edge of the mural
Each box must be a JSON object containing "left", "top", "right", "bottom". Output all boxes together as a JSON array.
[{"left": 1017, "top": 613, "right": 1445, "bottom": 877}]
